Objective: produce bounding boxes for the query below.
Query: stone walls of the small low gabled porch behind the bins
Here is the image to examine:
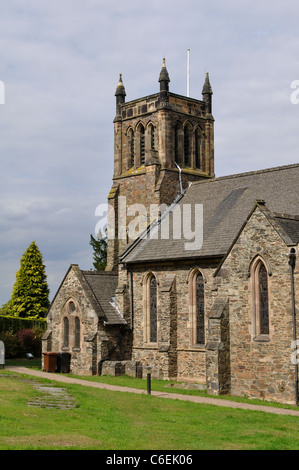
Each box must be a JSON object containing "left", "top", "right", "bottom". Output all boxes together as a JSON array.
[{"left": 42, "top": 265, "right": 131, "bottom": 375}]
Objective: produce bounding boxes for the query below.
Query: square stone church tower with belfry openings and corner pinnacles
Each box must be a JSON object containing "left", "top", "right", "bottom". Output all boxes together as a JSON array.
[{"left": 107, "top": 59, "right": 214, "bottom": 270}]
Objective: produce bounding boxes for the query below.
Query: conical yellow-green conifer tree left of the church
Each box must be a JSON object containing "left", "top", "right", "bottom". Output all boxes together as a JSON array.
[{"left": 11, "top": 241, "right": 50, "bottom": 318}]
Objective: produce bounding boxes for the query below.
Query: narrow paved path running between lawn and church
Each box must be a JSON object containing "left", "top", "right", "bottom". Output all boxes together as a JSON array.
[{"left": 5, "top": 366, "right": 299, "bottom": 417}]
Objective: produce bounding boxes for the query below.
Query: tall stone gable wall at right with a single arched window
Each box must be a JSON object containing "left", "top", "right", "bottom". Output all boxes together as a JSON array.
[{"left": 217, "top": 208, "right": 298, "bottom": 404}]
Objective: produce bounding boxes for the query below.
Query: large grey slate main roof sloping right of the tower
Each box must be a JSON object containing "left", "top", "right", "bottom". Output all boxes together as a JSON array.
[{"left": 121, "top": 164, "right": 299, "bottom": 263}]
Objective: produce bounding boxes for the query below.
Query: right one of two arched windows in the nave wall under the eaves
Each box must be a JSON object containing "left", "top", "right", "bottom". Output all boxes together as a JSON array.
[{"left": 188, "top": 268, "right": 205, "bottom": 345}]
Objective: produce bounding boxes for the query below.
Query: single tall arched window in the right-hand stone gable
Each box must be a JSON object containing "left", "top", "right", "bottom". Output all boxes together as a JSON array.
[{"left": 251, "top": 257, "right": 270, "bottom": 337}]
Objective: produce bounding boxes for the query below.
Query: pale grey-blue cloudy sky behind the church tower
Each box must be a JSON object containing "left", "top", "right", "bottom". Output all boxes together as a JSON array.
[{"left": 0, "top": 0, "right": 299, "bottom": 306}]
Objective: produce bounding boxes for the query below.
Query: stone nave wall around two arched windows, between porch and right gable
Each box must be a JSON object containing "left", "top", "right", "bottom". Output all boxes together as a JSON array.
[{"left": 120, "top": 263, "right": 216, "bottom": 383}]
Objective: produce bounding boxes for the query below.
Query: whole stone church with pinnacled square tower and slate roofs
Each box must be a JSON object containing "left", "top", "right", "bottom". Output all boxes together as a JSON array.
[{"left": 43, "top": 57, "right": 299, "bottom": 404}]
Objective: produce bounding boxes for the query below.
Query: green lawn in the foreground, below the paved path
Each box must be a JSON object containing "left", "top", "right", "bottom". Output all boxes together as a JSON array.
[{"left": 0, "top": 370, "right": 299, "bottom": 450}]
